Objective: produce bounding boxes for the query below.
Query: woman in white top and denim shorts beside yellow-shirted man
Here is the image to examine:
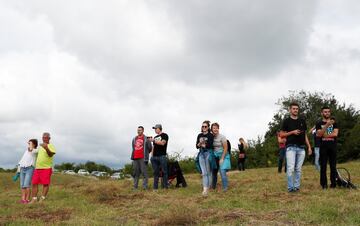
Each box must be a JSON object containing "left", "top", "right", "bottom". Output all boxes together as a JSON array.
[{"left": 19, "top": 139, "right": 38, "bottom": 204}]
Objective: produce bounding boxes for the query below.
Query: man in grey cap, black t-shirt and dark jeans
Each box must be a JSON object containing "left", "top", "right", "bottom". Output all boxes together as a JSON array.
[{"left": 151, "top": 124, "right": 169, "bottom": 190}]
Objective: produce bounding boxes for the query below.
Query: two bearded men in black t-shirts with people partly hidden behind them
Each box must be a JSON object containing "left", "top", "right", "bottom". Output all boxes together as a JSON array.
[{"left": 278, "top": 103, "right": 339, "bottom": 192}]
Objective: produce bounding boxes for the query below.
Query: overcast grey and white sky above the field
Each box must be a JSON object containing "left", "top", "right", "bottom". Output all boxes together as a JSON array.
[{"left": 0, "top": 0, "right": 360, "bottom": 168}]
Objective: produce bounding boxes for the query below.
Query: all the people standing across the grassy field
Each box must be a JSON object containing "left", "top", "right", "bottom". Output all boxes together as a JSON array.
[{"left": 13, "top": 103, "right": 339, "bottom": 204}]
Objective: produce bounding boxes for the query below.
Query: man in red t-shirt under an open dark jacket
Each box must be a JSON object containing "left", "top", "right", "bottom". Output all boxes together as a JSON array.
[{"left": 131, "top": 126, "right": 152, "bottom": 189}]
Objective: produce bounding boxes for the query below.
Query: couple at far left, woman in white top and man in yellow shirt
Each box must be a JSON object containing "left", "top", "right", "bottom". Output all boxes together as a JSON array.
[{"left": 19, "top": 132, "right": 56, "bottom": 204}]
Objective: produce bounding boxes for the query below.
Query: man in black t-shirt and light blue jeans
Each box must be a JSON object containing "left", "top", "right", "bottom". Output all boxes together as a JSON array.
[{"left": 280, "top": 103, "right": 311, "bottom": 192}]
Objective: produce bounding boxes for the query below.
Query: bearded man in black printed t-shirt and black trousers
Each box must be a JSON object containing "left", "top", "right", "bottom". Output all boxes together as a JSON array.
[{"left": 316, "top": 107, "right": 339, "bottom": 189}]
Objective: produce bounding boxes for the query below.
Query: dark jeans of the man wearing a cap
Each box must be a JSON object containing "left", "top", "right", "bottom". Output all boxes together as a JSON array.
[{"left": 150, "top": 155, "right": 168, "bottom": 189}]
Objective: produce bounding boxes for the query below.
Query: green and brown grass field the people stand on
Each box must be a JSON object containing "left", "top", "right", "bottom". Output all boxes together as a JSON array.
[{"left": 0, "top": 161, "right": 360, "bottom": 225}]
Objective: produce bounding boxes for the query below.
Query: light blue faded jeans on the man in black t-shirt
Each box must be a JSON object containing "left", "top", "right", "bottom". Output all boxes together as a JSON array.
[{"left": 286, "top": 146, "right": 305, "bottom": 191}]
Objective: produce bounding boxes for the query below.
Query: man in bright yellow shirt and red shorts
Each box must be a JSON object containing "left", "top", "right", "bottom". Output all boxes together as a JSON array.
[{"left": 31, "top": 133, "right": 56, "bottom": 203}]
